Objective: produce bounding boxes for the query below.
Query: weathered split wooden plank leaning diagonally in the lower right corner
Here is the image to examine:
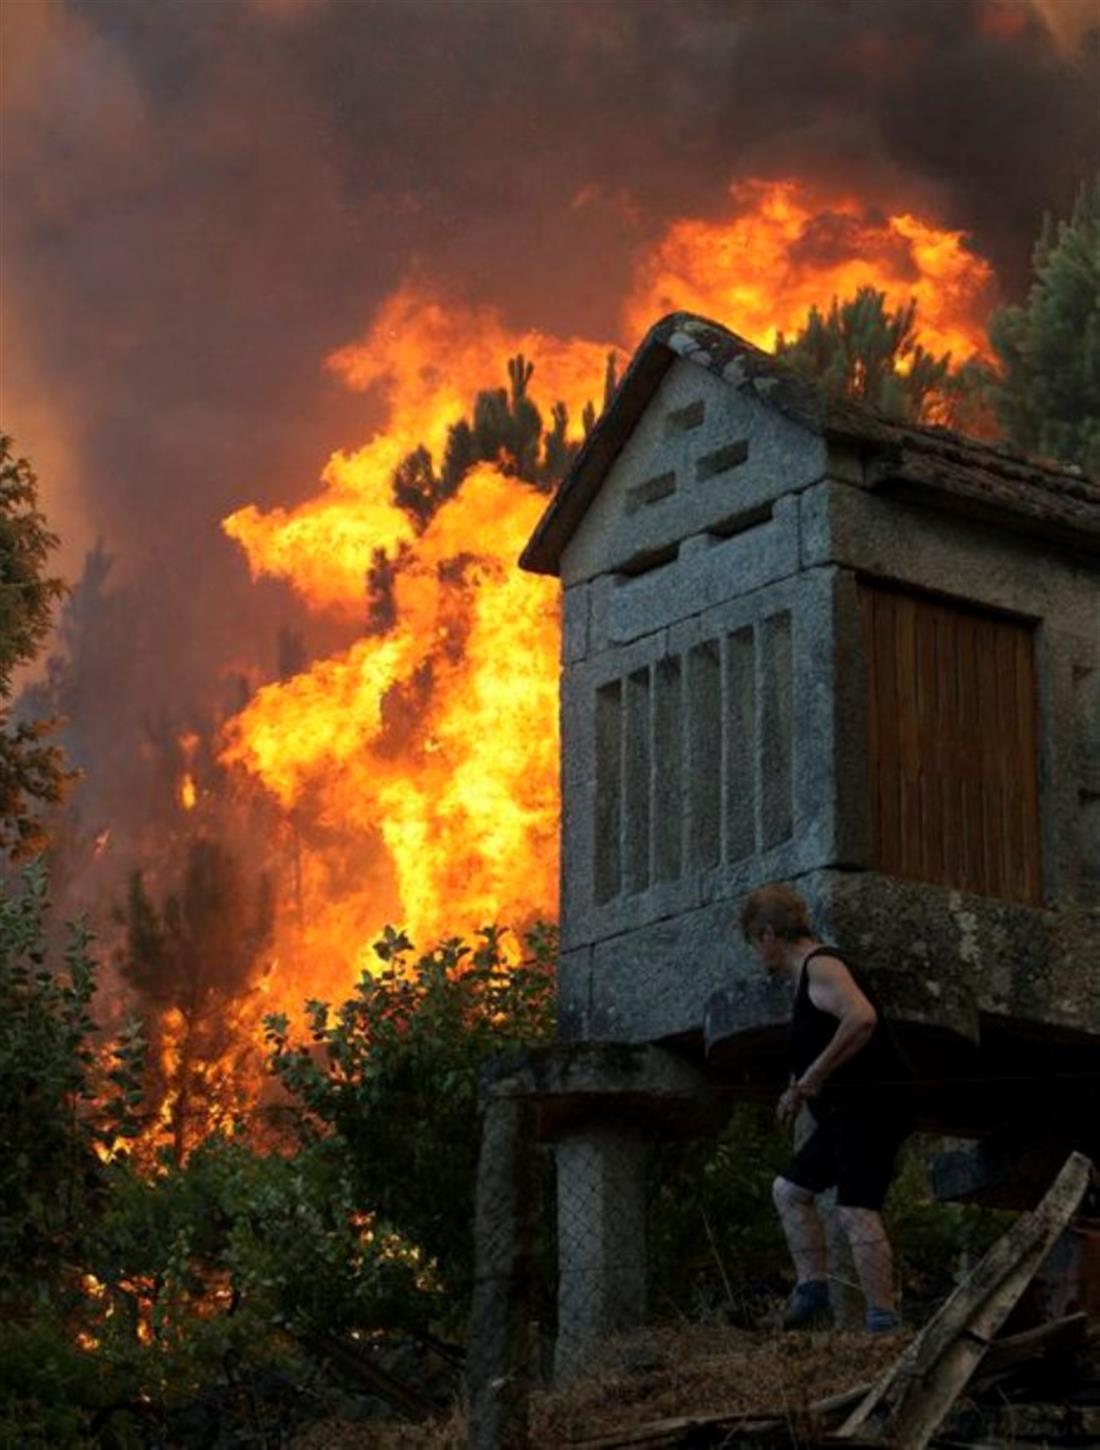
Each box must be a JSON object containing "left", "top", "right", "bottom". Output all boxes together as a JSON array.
[{"left": 835, "top": 1153, "right": 1093, "bottom": 1450}]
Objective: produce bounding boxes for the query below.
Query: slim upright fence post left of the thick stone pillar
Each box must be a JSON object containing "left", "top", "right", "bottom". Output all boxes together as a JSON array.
[{"left": 467, "top": 1077, "right": 533, "bottom": 1450}]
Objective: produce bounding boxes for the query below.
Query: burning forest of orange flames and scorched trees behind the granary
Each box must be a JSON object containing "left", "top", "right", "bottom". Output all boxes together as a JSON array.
[{"left": 0, "top": 180, "right": 1066, "bottom": 1154}]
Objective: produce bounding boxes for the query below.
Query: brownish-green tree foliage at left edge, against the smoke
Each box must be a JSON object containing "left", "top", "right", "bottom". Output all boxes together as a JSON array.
[{"left": 0, "top": 434, "right": 71, "bottom": 858}]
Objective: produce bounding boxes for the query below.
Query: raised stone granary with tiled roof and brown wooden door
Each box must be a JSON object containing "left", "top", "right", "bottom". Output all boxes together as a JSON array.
[{"left": 522, "top": 313, "right": 1100, "bottom": 1368}]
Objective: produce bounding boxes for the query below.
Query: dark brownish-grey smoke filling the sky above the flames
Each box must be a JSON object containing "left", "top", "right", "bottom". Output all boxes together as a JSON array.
[{"left": 3, "top": 0, "right": 1100, "bottom": 916}]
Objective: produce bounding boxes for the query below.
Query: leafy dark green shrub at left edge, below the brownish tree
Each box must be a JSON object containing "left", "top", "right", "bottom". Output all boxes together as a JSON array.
[{"left": 0, "top": 866, "right": 143, "bottom": 1317}]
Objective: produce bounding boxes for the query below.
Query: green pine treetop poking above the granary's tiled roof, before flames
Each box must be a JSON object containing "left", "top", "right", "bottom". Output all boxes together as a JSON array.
[{"left": 775, "top": 287, "right": 952, "bottom": 422}]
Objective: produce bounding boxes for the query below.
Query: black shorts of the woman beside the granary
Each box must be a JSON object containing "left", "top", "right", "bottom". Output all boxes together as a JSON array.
[{"left": 783, "top": 1112, "right": 910, "bottom": 1209}]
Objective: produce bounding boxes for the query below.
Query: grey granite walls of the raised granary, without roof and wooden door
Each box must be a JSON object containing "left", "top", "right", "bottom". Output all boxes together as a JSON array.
[{"left": 559, "top": 360, "right": 1100, "bottom": 1061}]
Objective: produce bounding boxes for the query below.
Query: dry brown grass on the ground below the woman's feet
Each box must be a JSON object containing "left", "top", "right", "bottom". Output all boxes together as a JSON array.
[{"left": 294, "top": 1327, "right": 906, "bottom": 1450}]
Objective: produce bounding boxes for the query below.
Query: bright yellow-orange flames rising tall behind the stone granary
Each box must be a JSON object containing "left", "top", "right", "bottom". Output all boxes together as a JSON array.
[{"left": 223, "top": 181, "right": 991, "bottom": 1006}]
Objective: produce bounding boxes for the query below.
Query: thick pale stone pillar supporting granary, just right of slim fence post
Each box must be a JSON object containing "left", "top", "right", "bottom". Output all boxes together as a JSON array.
[{"left": 554, "top": 1128, "right": 646, "bottom": 1380}]
